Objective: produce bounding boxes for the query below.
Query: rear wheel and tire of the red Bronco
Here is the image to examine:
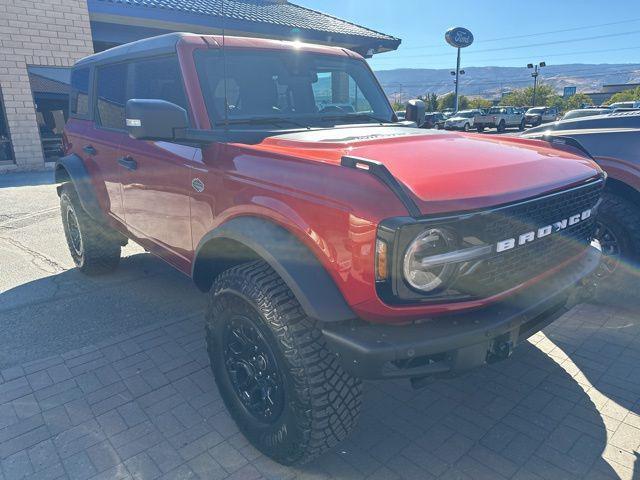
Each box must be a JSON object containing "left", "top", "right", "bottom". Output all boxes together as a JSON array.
[{"left": 60, "top": 183, "right": 121, "bottom": 275}]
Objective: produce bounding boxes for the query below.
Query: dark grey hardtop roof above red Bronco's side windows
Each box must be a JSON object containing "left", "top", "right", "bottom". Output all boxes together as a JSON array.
[{"left": 75, "top": 32, "right": 190, "bottom": 67}]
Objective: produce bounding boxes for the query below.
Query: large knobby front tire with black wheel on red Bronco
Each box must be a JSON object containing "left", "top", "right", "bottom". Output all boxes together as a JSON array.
[{"left": 206, "top": 261, "right": 362, "bottom": 465}]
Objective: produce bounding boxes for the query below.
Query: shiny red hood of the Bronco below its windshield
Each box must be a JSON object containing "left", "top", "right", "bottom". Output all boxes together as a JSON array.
[{"left": 248, "top": 126, "right": 601, "bottom": 214}]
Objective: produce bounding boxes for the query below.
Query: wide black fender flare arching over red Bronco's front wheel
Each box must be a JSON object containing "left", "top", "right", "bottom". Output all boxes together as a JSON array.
[{"left": 191, "top": 216, "right": 356, "bottom": 322}]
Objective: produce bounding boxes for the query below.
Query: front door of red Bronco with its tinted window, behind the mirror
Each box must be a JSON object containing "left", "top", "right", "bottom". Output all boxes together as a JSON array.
[{"left": 118, "top": 55, "right": 198, "bottom": 271}]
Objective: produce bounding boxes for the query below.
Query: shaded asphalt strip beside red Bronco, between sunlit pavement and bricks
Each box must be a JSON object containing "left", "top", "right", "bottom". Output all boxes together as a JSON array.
[{"left": 0, "top": 253, "right": 205, "bottom": 369}]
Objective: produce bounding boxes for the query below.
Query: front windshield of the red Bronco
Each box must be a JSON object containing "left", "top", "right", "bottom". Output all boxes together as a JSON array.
[{"left": 196, "top": 49, "right": 393, "bottom": 128}]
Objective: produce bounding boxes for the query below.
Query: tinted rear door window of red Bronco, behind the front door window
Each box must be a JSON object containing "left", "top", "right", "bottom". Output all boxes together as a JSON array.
[{"left": 96, "top": 63, "right": 127, "bottom": 129}]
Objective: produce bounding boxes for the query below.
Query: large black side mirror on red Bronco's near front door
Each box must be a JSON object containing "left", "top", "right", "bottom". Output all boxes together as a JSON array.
[{"left": 126, "top": 98, "right": 189, "bottom": 141}]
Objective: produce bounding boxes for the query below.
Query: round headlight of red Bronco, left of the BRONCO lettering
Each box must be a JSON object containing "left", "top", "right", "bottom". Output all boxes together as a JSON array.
[{"left": 403, "top": 228, "right": 457, "bottom": 292}]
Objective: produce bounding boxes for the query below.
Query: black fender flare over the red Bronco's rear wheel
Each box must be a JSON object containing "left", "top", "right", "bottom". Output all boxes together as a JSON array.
[{"left": 54, "top": 153, "right": 108, "bottom": 225}]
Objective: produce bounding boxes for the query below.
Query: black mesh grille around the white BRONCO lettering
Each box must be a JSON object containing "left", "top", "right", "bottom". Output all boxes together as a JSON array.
[{"left": 455, "top": 181, "right": 603, "bottom": 297}]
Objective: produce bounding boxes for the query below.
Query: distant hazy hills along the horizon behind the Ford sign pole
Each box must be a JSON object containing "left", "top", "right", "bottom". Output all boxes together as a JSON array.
[{"left": 376, "top": 63, "right": 640, "bottom": 100}]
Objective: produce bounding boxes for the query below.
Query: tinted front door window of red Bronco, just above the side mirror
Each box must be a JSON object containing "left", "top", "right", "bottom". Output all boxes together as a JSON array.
[{"left": 128, "top": 56, "right": 187, "bottom": 110}]
